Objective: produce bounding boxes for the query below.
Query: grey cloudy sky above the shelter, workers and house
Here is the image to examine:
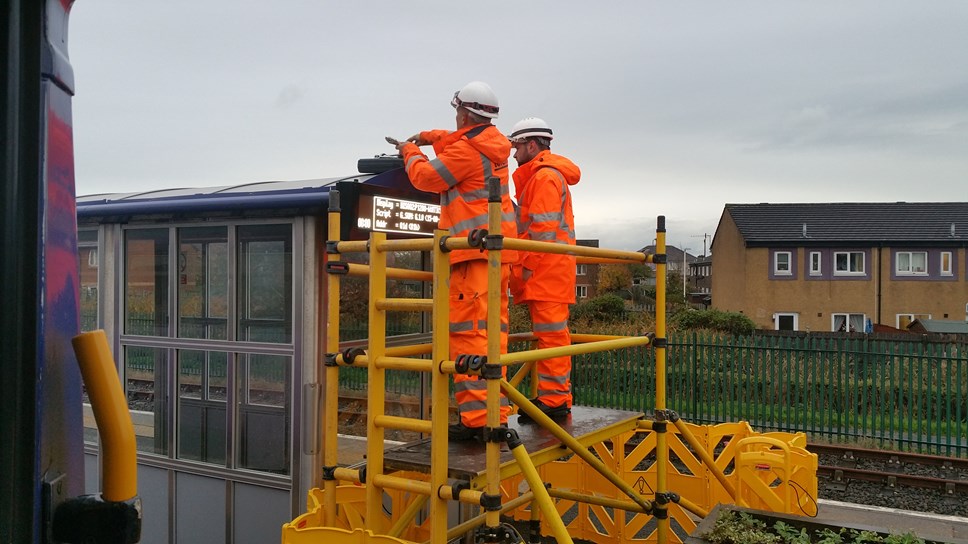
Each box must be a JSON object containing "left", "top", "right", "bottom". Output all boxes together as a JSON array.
[{"left": 69, "top": 0, "right": 968, "bottom": 254}]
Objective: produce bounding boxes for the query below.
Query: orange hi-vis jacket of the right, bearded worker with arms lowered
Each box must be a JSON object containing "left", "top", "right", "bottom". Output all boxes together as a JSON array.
[{"left": 511, "top": 150, "right": 581, "bottom": 304}]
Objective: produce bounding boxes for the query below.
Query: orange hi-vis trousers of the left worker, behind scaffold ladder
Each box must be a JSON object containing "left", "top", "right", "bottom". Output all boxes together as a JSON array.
[{"left": 450, "top": 259, "right": 511, "bottom": 427}]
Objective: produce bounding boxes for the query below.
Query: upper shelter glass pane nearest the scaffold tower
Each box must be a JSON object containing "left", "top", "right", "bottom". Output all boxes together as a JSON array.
[{"left": 238, "top": 225, "right": 292, "bottom": 344}]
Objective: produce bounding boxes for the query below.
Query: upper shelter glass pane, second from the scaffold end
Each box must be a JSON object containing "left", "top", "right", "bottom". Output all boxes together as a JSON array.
[{"left": 178, "top": 227, "right": 229, "bottom": 340}]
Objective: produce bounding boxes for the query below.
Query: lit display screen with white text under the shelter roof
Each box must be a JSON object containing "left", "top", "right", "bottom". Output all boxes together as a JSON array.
[{"left": 356, "top": 194, "right": 440, "bottom": 236}]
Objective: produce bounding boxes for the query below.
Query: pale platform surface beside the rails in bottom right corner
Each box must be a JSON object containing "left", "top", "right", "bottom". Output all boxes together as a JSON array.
[{"left": 812, "top": 499, "right": 968, "bottom": 544}]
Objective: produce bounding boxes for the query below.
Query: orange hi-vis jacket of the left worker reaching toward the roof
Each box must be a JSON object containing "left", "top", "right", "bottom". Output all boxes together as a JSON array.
[{"left": 401, "top": 124, "right": 520, "bottom": 268}]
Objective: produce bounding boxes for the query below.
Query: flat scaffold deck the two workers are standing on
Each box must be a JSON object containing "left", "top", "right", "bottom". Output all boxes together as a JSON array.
[{"left": 384, "top": 406, "right": 644, "bottom": 482}]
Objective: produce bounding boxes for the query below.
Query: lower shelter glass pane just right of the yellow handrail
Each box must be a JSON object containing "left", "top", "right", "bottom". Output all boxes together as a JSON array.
[{"left": 124, "top": 346, "right": 168, "bottom": 455}]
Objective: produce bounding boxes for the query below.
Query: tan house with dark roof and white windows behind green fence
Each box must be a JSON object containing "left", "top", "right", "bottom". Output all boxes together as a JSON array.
[{"left": 712, "top": 202, "right": 968, "bottom": 332}]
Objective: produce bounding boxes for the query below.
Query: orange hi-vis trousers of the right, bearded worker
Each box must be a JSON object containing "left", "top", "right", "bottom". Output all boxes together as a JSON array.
[{"left": 527, "top": 300, "right": 571, "bottom": 408}]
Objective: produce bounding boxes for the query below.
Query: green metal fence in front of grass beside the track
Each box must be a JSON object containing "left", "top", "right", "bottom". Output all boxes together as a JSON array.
[{"left": 572, "top": 333, "right": 968, "bottom": 457}]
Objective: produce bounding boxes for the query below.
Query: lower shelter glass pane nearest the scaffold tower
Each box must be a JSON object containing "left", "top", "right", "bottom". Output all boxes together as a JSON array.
[{"left": 239, "top": 354, "right": 291, "bottom": 474}]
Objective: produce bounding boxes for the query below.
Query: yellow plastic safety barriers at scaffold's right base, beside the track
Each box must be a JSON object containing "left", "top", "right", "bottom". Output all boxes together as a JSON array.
[{"left": 502, "top": 422, "right": 817, "bottom": 543}]
